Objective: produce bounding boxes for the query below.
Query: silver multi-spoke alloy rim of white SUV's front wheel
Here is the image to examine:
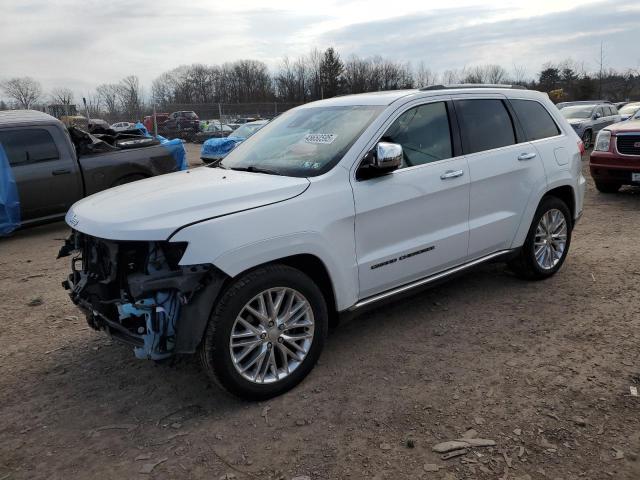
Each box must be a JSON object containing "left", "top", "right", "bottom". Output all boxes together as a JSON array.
[{"left": 229, "top": 287, "right": 315, "bottom": 384}]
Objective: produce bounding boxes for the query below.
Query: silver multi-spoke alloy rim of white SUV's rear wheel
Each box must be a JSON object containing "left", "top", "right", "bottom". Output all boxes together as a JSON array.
[{"left": 533, "top": 208, "right": 567, "bottom": 270}]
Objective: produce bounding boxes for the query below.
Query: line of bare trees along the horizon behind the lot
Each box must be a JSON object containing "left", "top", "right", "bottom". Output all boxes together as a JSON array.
[{"left": 0, "top": 48, "right": 640, "bottom": 121}]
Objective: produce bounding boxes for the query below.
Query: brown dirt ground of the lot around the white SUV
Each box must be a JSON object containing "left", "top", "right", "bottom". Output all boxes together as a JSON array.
[{"left": 0, "top": 146, "right": 640, "bottom": 480}]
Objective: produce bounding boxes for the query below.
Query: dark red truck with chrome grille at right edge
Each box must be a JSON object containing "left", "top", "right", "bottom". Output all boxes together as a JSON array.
[{"left": 589, "top": 120, "right": 640, "bottom": 193}]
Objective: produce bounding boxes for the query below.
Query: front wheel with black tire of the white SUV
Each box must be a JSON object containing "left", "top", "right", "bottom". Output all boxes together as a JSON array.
[{"left": 200, "top": 265, "right": 328, "bottom": 400}]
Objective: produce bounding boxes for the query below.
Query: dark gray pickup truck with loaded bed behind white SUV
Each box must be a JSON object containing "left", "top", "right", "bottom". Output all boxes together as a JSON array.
[{"left": 0, "top": 110, "right": 186, "bottom": 230}]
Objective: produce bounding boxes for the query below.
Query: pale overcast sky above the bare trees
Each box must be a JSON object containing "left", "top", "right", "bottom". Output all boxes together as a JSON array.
[{"left": 0, "top": 0, "right": 640, "bottom": 99}]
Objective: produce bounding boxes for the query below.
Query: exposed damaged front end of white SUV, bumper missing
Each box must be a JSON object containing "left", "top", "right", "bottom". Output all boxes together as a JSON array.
[{"left": 58, "top": 231, "right": 226, "bottom": 360}]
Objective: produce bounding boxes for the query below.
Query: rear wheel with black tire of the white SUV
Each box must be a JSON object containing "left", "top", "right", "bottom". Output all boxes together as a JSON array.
[{"left": 509, "top": 196, "right": 572, "bottom": 280}]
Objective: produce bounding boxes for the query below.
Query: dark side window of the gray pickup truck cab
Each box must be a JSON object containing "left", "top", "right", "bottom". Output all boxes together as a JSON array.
[{"left": 0, "top": 128, "right": 60, "bottom": 165}]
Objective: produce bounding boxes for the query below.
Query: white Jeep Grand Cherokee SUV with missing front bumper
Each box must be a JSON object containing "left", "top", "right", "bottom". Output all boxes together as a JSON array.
[{"left": 61, "top": 86, "right": 585, "bottom": 399}]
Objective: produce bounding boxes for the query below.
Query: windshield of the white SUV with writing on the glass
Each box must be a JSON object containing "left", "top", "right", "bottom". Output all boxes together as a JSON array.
[{"left": 218, "top": 105, "right": 384, "bottom": 177}]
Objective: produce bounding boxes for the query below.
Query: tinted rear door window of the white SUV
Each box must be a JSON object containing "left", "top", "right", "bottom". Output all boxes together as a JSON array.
[{"left": 455, "top": 99, "right": 516, "bottom": 153}]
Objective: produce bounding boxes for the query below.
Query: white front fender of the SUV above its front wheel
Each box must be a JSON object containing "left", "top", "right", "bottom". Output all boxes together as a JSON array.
[{"left": 171, "top": 171, "right": 358, "bottom": 311}]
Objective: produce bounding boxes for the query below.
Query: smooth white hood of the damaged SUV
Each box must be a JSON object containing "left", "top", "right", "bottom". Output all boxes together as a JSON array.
[{"left": 66, "top": 167, "right": 309, "bottom": 241}]
